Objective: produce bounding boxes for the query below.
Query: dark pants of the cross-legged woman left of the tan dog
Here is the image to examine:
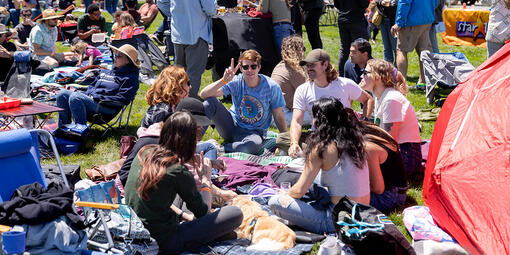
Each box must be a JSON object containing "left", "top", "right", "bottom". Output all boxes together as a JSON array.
[{"left": 158, "top": 206, "right": 243, "bottom": 254}]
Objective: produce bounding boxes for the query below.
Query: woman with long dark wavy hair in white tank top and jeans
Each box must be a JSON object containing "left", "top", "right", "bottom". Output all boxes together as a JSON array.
[{"left": 269, "top": 98, "right": 370, "bottom": 234}]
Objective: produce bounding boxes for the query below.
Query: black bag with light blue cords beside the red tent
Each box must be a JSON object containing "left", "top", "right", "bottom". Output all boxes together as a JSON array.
[{"left": 331, "top": 196, "right": 416, "bottom": 255}]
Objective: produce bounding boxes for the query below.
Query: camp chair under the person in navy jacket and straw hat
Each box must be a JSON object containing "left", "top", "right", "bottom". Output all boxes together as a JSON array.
[{"left": 87, "top": 100, "right": 134, "bottom": 136}]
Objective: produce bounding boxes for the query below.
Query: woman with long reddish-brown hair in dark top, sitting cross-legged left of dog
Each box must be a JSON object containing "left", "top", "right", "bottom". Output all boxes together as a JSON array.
[{"left": 126, "top": 112, "right": 243, "bottom": 254}]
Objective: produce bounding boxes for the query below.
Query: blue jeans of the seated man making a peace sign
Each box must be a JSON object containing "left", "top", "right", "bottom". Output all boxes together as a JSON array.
[{"left": 204, "top": 97, "right": 263, "bottom": 154}]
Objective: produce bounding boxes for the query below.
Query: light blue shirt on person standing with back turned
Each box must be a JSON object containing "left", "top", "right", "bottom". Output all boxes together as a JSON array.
[{"left": 170, "top": 0, "right": 216, "bottom": 45}]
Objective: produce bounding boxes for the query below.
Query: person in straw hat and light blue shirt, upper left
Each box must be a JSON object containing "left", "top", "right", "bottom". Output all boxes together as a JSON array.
[{"left": 28, "top": 9, "right": 64, "bottom": 67}]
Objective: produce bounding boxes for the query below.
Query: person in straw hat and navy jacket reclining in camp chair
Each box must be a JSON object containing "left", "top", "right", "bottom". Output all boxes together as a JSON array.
[{"left": 57, "top": 44, "right": 142, "bottom": 127}]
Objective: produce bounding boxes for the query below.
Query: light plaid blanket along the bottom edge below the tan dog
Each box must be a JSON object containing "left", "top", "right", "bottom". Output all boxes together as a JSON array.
[{"left": 181, "top": 239, "right": 313, "bottom": 255}]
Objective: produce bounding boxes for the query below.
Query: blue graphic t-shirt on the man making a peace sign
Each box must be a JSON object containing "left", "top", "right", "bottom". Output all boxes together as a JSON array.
[{"left": 221, "top": 74, "right": 285, "bottom": 133}]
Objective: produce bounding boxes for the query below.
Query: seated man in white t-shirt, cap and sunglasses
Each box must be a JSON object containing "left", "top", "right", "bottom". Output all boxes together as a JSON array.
[{"left": 277, "top": 49, "right": 374, "bottom": 158}]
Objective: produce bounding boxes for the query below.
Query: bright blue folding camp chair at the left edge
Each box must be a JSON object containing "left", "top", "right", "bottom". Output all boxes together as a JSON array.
[{"left": 0, "top": 128, "right": 69, "bottom": 203}]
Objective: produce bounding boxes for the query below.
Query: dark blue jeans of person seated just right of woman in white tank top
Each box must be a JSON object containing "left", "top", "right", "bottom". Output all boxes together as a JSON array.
[{"left": 370, "top": 187, "right": 408, "bottom": 212}]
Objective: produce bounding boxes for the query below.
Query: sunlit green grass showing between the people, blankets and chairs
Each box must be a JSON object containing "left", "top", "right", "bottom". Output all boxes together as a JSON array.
[{"left": 48, "top": 7, "right": 486, "bottom": 249}]
